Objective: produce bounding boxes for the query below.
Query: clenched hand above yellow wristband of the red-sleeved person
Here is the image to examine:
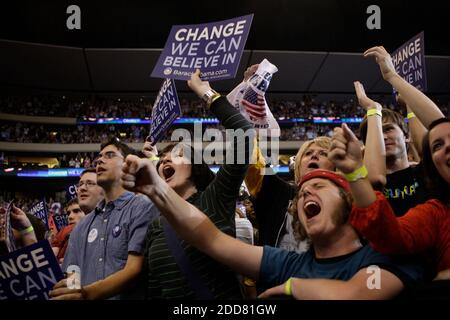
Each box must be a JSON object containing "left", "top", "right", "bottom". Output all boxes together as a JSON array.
[{"left": 328, "top": 123, "right": 363, "bottom": 173}]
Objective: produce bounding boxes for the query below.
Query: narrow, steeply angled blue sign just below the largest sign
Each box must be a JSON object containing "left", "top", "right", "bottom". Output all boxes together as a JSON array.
[{"left": 150, "top": 79, "right": 181, "bottom": 143}]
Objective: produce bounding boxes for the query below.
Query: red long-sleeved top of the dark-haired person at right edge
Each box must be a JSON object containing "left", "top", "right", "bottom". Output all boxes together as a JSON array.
[{"left": 350, "top": 192, "right": 450, "bottom": 272}]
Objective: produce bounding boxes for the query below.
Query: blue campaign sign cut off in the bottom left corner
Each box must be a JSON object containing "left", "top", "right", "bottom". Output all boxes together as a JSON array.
[{"left": 0, "top": 240, "right": 63, "bottom": 300}]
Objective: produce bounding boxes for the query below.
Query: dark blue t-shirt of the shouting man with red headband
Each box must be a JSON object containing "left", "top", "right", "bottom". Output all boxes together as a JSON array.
[{"left": 258, "top": 245, "right": 423, "bottom": 290}]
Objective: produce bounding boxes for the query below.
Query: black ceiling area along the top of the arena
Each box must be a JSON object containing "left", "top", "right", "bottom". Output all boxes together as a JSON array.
[{"left": 0, "top": 0, "right": 450, "bottom": 56}]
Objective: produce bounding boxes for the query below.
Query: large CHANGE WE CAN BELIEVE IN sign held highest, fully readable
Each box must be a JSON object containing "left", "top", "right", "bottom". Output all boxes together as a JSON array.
[{"left": 151, "top": 14, "right": 253, "bottom": 81}]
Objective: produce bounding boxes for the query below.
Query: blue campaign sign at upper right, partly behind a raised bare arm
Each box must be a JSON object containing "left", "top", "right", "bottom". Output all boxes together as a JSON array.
[{"left": 391, "top": 31, "right": 427, "bottom": 91}]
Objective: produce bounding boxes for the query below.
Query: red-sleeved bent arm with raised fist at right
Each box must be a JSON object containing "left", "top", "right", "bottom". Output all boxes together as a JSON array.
[{"left": 328, "top": 124, "right": 446, "bottom": 268}]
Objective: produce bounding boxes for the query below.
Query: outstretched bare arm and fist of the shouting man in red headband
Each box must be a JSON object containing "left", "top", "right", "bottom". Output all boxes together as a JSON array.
[{"left": 122, "top": 155, "right": 263, "bottom": 279}]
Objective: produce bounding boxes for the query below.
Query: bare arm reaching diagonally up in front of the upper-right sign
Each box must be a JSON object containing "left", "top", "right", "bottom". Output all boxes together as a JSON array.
[{"left": 364, "top": 47, "right": 444, "bottom": 128}]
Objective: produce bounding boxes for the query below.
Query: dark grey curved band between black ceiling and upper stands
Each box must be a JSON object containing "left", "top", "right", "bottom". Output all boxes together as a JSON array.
[{"left": 0, "top": 40, "right": 450, "bottom": 94}]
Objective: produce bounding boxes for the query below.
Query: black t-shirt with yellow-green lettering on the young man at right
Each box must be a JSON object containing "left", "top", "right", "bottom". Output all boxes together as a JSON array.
[{"left": 383, "top": 164, "right": 429, "bottom": 217}]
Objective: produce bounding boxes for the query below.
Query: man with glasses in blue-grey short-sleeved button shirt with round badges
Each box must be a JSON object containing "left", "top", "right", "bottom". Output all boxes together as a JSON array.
[{"left": 50, "top": 138, "right": 159, "bottom": 300}]
